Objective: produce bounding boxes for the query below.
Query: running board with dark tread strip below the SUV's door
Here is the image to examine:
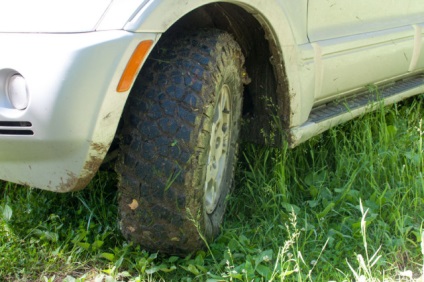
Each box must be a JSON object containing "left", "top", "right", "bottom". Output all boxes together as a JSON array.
[{"left": 289, "top": 74, "right": 424, "bottom": 147}]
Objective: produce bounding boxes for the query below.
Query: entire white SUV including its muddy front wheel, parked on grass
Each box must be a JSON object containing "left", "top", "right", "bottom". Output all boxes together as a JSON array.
[{"left": 0, "top": 0, "right": 424, "bottom": 254}]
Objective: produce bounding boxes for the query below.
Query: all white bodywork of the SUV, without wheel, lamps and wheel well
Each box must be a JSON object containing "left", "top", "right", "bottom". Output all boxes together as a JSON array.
[{"left": 0, "top": 0, "right": 424, "bottom": 192}]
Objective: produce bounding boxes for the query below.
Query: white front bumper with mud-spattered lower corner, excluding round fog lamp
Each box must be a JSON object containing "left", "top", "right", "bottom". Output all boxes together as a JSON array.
[{"left": 0, "top": 31, "right": 157, "bottom": 192}]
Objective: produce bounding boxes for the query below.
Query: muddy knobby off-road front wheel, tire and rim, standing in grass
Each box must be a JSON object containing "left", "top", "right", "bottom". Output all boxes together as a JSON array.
[{"left": 116, "top": 30, "right": 247, "bottom": 255}]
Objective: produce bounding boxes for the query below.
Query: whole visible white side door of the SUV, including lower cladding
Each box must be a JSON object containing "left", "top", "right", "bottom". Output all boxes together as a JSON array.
[{"left": 307, "top": 0, "right": 424, "bottom": 104}]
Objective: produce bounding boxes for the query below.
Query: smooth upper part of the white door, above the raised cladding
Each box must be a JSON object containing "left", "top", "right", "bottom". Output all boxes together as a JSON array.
[{"left": 308, "top": 0, "right": 424, "bottom": 42}]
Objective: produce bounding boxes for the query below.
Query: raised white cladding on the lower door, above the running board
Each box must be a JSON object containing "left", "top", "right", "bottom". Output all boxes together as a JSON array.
[{"left": 304, "top": 26, "right": 423, "bottom": 104}]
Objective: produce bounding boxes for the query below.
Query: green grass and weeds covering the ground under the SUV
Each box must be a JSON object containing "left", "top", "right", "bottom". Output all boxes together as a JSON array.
[{"left": 0, "top": 96, "right": 424, "bottom": 281}]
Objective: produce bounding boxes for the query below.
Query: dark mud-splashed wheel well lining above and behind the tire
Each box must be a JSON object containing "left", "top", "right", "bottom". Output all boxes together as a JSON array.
[{"left": 154, "top": 3, "right": 289, "bottom": 144}]
